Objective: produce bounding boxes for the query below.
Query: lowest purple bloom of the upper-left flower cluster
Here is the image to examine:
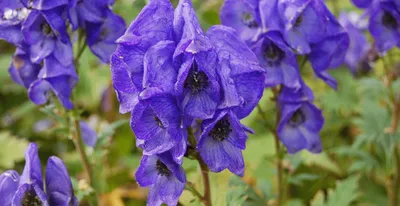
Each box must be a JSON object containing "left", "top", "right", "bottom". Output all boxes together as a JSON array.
[{"left": 28, "top": 56, "right": 78, "bottom": 109}]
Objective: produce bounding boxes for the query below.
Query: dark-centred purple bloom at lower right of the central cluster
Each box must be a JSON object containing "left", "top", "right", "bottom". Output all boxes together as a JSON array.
[{"left": 197, "top": 110, "right": 247, "bottom": 176}]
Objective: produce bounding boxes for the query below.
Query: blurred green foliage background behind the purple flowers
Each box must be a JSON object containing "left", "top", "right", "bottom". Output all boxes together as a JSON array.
[{"left": 0, "top": 0, "right": 400, "bottom": 206}]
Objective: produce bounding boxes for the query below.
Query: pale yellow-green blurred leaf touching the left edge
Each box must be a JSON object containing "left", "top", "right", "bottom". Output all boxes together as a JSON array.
[{"left": 0, "top": 131, "right": 28, "bottom": 169}]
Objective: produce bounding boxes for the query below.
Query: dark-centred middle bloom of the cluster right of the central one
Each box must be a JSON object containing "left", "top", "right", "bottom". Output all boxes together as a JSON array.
[{"left": 252, "top": 31, "right": 300, "bottom": 88}]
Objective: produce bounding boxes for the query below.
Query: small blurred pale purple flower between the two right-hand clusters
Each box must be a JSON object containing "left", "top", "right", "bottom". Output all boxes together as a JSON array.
[{"left": 339, "top": 12, "right": 371, "bottom": 75}]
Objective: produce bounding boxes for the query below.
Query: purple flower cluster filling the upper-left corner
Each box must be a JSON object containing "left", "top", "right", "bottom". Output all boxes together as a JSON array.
[{"left": 0, "top": 0, "right": 125, "bottom": 109}]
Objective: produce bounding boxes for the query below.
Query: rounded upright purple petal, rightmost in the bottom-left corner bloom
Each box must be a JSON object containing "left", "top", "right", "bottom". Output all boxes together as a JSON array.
[{"left": 46, "top": 156, "right": 78, "bottom": 206}]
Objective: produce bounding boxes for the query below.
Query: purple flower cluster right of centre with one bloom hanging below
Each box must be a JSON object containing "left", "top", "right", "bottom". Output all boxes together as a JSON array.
[{"left": 220, "top": 0, "right": 349, "bottom": 153}]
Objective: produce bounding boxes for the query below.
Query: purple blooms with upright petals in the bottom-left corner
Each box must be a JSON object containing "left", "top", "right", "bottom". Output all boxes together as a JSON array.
[{"left": 0, "top": 143, "right": 78, "bottom": 206}]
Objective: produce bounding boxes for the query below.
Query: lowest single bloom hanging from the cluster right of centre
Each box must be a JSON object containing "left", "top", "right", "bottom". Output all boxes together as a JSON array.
[{"left": 278, "top": 101, "right": 324, "bottom": 154}]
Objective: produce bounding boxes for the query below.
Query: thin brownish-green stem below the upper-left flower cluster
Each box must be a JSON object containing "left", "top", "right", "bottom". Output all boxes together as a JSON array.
[{"left": 72, "top": 114, "right": 93, "bottom": 187}]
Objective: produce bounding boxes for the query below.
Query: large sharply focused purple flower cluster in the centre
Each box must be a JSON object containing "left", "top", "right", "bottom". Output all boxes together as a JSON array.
[{"left": 111, "top": 0, "right": 264, "bottom": 205}]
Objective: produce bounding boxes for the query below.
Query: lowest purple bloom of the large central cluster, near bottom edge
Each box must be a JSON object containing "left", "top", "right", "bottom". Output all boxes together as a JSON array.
[{"left": 135, "top": 153, "right": 186, "bottom": 206}]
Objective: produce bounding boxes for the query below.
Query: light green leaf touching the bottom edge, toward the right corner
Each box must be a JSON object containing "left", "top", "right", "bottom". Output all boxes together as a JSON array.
[{"left": 313, "top": 176, "right": 359, "bottom": 206}]
